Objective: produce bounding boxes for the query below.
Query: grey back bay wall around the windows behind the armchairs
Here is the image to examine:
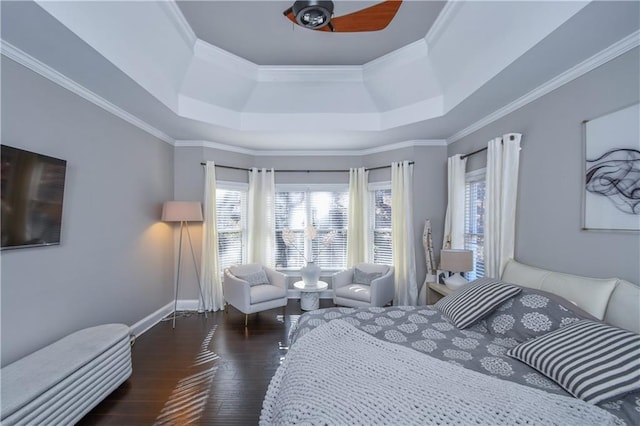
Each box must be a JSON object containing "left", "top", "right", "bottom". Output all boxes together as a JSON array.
[{"left": 175, "top": 145, "right": 447, "bottom": 299}]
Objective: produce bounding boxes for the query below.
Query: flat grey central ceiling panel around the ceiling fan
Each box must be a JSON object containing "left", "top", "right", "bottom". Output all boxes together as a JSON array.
[{"left": 177, "top": 0, "right": 446, "bottom": 65}]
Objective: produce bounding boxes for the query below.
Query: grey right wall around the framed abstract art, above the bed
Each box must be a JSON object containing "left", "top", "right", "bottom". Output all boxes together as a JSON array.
[{"left": 448, "top": 48, "right": 640, "bottom": 285}]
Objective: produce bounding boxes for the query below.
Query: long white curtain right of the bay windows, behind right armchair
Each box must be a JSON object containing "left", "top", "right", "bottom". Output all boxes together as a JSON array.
[{"left": 391, "top": 161, "right": 418, "bottom": 305}]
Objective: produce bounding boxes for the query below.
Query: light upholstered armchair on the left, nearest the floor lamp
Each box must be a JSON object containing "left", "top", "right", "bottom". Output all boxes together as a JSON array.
[{"left": 222, "top": 263, "right": 287, "bottom": 327}]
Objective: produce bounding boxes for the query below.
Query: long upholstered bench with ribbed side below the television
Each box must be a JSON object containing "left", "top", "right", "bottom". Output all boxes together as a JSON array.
[{"left": 0, "top": 324, "right": 131, "bottom": 426}]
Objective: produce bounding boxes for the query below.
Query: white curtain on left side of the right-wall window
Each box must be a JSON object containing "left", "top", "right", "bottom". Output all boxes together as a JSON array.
[{"left": 442, "top": 154, "right": 467, "bottom": 249}]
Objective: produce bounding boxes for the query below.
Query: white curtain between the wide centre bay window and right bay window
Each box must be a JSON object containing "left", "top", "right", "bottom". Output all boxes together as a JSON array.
[{"left": 347, "top": 167, "right": 369, "bottom": 268}]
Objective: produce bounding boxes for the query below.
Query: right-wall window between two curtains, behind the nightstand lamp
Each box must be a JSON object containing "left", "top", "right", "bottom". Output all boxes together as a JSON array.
[{"left": 464, "top": 169, "right": 486, "bottom": 281}]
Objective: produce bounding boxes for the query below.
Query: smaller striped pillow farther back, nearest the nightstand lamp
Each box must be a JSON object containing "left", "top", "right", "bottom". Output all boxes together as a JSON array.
[{"left": 435, "top": 278, "right": 521, "bottom": 328}]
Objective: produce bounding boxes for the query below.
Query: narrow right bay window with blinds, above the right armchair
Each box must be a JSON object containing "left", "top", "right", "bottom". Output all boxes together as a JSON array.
[{"left": 369, "top": 183, "right": 393, "bottom": 265}]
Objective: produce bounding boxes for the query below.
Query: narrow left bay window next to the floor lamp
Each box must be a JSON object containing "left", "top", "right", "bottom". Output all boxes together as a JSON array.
[{"left": 216, "top": 182, "right": 247, "bottom": 272}]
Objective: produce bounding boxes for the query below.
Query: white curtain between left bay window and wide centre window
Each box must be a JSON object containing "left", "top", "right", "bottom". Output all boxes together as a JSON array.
[{"left": 247, "top": 167, "right": 276, "bottom": 268}]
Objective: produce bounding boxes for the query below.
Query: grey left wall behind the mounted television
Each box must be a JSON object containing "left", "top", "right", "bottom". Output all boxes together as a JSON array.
[{"left": 1, "top": 56, "right": 173, "bottom": 366}]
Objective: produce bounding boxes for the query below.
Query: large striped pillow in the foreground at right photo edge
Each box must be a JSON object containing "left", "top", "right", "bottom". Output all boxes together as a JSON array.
[{"left": 507, "top": 320, "right": 640, "bottom": 404}]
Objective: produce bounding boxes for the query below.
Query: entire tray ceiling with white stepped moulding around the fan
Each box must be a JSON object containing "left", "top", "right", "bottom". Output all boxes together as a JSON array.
[{"left": 1, "top": 1, "right": 640, "bottom": 153}]
